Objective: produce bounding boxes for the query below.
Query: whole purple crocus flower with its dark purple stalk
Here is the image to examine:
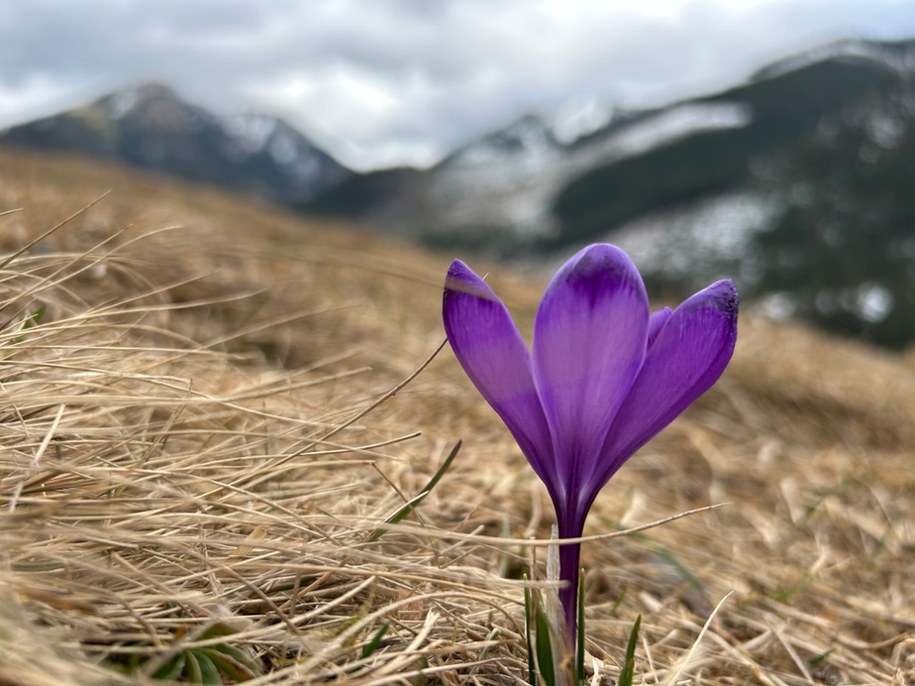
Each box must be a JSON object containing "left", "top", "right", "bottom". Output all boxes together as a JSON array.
[{"left": 443, "top": 244, "right": 738, "bottom": 642}]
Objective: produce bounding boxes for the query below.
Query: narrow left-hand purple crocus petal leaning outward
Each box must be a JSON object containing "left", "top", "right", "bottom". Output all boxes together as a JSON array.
[{"left": 442, "top": 260, "right": 556, "bottom": 486}]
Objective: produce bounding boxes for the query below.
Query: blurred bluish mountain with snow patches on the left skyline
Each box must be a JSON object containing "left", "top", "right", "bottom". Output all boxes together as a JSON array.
[{"left": 0, "top": 84, "right": 351, "bottom": 205}]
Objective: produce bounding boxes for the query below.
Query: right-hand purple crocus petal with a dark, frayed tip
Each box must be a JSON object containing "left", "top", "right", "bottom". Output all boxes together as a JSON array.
[{"left": 596, "top": 280, "right": 738, "bottom": 486}]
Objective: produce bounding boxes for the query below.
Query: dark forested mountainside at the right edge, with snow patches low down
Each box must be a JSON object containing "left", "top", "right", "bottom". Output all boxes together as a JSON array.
[{"left": 580, "top": 41, "right": 915, "bottom": 348}]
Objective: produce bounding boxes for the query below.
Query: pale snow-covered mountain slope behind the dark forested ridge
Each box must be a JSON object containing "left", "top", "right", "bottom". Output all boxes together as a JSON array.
[{"left": 306, "top": 102, "right": 752, "bottom": 244}]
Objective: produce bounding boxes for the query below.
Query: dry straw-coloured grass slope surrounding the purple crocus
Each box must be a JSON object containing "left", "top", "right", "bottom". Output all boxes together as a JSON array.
[{"left": 0, "top": 151, "right": 915, "bottom": 686}]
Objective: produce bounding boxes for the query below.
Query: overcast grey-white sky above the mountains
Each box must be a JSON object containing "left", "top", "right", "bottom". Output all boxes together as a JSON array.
[{"left": 0, "top": 0, "right": 915, "bottom": 169}]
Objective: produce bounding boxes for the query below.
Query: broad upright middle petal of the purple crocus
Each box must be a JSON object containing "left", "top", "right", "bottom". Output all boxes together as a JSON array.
[{"left": 534, "top": 244, "right": 649, "bottom": 502}]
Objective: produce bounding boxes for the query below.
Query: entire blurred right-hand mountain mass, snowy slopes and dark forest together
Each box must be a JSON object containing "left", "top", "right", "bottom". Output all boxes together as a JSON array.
[{"left": 305, "top": 40, "right": 915, "bottom": 347}]
